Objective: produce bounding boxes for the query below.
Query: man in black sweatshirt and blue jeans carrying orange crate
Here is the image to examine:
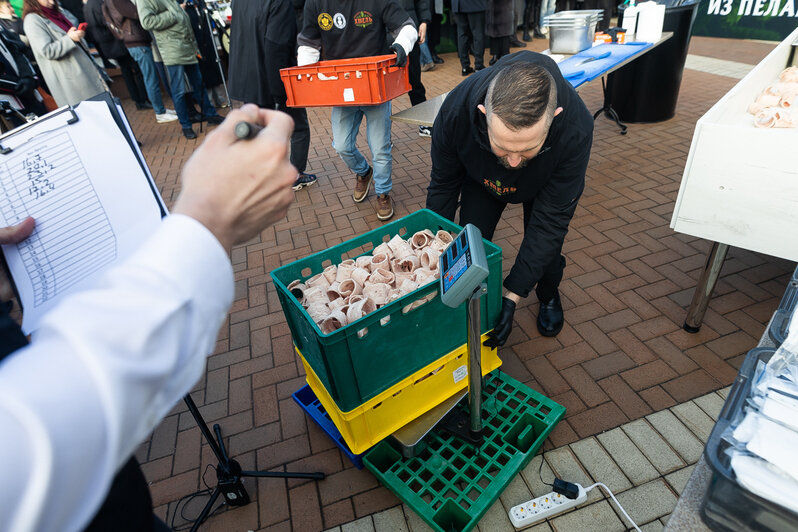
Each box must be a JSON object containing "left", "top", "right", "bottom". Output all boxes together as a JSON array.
[{"left": 297, "top": 0, "right": 418, "bottom": 221}]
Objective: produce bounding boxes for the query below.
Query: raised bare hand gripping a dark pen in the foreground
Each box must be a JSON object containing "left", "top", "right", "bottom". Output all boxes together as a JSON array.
[{"left": 172, "top": 104, "right": 297, "bottom": 249}]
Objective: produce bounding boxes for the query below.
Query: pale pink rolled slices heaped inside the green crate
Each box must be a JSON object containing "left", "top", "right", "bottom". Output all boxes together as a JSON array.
[{"left": 288, "top": 229, "right": 454, "bottom": 334}]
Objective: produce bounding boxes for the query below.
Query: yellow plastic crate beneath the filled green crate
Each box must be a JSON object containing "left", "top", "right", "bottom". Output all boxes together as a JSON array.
[{"left": 294, "top": 334, "right": 502, "bottom": 454}]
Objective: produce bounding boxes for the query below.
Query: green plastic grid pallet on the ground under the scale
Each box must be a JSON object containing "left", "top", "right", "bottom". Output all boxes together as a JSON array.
[{"left": 363, "top": 371, "right": 565, "bottom": 532}]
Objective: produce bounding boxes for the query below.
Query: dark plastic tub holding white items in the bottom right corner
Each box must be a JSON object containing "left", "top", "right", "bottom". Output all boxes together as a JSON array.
[{"left": 701, "top": 347, "right": 798, "bottom": 532}]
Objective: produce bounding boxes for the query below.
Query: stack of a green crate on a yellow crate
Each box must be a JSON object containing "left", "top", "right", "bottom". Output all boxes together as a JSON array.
[{"left": 271, "top": 209, "right": 502, "bottom": 454}]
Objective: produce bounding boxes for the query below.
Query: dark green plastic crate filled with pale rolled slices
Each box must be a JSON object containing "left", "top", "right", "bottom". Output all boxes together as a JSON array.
[{"left": 271, "top": 209, "right": 502, "bottom": 412}]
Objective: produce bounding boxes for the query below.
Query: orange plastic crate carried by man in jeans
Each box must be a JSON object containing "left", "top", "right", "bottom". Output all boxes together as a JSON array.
[{"left": 280, "top": 54, "right": 410, "bottom": 107}]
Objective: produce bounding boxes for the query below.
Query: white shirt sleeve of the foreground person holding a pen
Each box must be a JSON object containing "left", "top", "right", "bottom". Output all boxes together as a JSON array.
[{"left": 0, "top": 215, "right": 233, "bottom": 532}]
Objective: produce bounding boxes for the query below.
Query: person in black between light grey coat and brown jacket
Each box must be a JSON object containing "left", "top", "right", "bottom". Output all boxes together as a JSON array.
[{"left": 83, "top": 0, "right": 152, "bottom": 111}]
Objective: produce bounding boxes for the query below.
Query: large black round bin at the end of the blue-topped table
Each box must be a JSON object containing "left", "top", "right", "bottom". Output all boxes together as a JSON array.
[{"left": 604, "top": 0, "right": 698, "bottom": 122}]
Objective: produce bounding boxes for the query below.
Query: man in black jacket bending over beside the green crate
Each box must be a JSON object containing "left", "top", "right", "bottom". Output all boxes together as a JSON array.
[{"left": 427, "top": 52, "right": 593, "bottom": 346}]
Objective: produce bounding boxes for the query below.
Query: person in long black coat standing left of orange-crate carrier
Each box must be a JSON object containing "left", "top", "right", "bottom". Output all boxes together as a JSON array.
[{"left": 228, "top": 0, "right": 317, "bottom": 190}]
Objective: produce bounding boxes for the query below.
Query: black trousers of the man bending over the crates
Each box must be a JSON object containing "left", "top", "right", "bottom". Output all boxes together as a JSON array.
[{"left": 460, "top": 178, "right": 565, "bottom": 302}]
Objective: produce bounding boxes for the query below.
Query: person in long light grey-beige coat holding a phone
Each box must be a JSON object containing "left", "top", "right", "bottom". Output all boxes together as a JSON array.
[{"left": 22, "top": 0, "right": 108, "bottom": 106}]
